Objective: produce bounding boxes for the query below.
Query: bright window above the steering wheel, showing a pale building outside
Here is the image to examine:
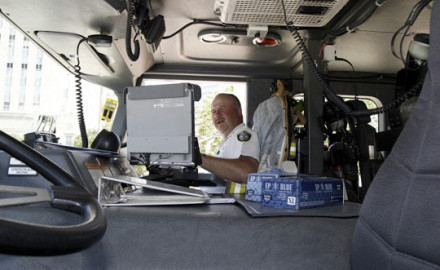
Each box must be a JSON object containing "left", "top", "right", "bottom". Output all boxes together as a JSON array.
[{"left": 0, "top": 18, "right": 117, "bottom": 146}]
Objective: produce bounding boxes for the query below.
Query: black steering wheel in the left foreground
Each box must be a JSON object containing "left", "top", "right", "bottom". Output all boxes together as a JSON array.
[{"left": 0, "top": 131, "right": 107, "bottom": 255}]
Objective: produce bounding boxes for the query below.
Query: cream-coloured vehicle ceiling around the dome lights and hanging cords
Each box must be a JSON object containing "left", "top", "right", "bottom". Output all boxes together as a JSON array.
[{"left": 0, "top": 0, "right": 430, "bottom": 91}]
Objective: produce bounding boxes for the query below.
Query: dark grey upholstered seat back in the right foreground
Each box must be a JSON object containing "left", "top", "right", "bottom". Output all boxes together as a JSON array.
[{"left": 351, "top": 1, "right": 440, "bottom": 269}]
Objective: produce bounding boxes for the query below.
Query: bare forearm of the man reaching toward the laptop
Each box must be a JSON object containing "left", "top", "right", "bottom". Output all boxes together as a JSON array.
[{"left": 201, "top": 155, "right": 258, "bottom": 183}]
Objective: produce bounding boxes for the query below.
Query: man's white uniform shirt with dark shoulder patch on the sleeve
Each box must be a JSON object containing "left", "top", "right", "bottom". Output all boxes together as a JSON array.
[{"left": 217, "top": 123, "right": 260, "bottom": 193}]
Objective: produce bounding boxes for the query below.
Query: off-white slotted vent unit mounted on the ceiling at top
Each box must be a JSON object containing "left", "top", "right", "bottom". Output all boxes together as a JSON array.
[{"left": 214, "top": 0, "right": 349, "bottom": 27}]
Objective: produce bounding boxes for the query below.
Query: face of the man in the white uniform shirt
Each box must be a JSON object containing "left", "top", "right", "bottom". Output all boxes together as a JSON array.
[{"left": 211, "top": 95, "right": 243, "bottom": 138}]
